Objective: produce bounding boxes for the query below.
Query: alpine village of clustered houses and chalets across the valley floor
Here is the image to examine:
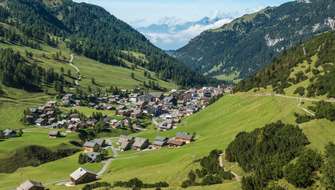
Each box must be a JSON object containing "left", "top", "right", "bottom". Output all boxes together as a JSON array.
[{"left": 11, "top": 86, "right": 231, "bottom": 190}]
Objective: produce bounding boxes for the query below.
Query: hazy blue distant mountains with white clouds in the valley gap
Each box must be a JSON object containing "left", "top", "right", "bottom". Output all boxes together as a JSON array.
[{"left": 137, "top": 16, "right": 233, "bottom": 50}]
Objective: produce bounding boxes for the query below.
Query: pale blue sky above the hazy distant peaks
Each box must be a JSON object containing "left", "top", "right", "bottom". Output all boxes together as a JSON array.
[{"left": 75, "top": 0, "right": 288, "bottom": 25}]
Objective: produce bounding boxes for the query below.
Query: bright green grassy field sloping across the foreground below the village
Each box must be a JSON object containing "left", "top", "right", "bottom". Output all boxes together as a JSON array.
[{"left": 0, "top": 94, "right": 335, "bottom": 190}]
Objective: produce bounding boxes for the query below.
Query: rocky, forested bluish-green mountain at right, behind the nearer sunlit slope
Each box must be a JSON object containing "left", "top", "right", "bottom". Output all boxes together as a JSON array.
[{"left": 175, "top": 0, "right": 335, "bottom": 78}]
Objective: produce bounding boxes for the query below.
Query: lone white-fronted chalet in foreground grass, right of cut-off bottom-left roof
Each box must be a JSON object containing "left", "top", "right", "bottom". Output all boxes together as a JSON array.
[{"left": 70, "top": 168, "right": 98, "bottom": 185}]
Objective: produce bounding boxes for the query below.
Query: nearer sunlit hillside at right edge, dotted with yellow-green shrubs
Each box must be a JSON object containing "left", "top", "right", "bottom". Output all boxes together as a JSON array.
[{"left": 236, "top": 32, "right": 335, "bottom": 98}]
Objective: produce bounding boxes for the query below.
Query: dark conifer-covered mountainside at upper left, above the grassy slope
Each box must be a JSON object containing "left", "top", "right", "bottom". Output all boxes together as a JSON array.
[{"left": 1, "top": 0, "right": 209, "bottom": 86}]
